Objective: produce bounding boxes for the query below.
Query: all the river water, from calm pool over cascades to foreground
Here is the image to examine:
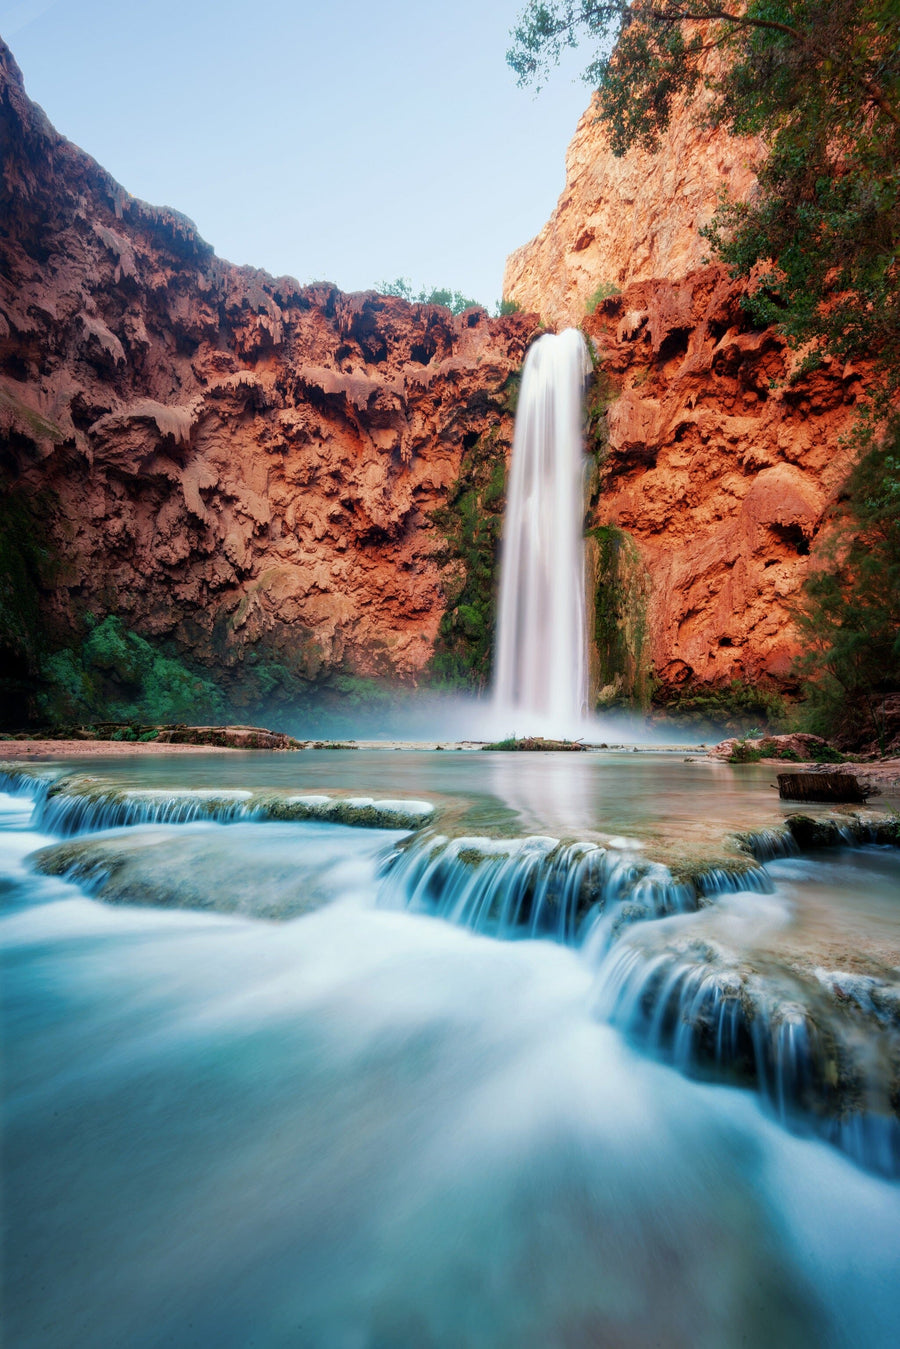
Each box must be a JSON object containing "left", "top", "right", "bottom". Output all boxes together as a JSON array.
[{"left": 0, "top": 751, "right": 900, "bottom": 1349}]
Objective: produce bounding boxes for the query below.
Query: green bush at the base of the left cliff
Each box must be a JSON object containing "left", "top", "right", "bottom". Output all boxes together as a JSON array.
[{"left": 35, "top": 614, "right": 225, "bottom": 724}]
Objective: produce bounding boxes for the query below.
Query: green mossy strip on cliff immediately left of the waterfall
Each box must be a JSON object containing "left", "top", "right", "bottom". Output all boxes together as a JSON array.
[{"left": 430, "top": 426, "right": 514, "bottom": 689}]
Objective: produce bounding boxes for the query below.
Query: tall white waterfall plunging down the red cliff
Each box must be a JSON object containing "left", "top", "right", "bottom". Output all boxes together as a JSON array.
[{"left": 494, "top": 328, "right": 591, "bottom": 734}]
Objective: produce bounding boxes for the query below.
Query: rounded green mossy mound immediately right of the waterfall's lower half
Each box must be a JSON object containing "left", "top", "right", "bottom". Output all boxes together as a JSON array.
[{"left": 587, "top": 525, "right": 653, "bottom": 708}]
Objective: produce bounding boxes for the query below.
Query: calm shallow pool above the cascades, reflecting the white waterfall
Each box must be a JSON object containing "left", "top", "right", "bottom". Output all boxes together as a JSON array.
[{"left": 28, "top": 749, "right": 804, "bottom": 839}]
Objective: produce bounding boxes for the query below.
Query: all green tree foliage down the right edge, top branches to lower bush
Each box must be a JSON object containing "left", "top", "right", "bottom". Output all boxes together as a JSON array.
[{"left": 507, "top": 0, "right": 900, "bottom": 746}]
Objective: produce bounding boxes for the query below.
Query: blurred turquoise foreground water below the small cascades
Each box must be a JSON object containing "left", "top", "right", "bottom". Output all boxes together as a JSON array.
[{"left": 0, "top": 797, "right": 900, "bottom": 1349}]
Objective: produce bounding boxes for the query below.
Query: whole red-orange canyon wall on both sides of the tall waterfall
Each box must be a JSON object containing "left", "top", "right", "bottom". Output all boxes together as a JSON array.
[{"left": 0, "top": 31, "right": 865, "bottom": 723}]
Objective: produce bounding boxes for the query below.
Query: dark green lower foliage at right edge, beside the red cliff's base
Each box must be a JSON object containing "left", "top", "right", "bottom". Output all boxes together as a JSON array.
[{"left": 796, "top": 415, "right": 900, "bottom": 749}]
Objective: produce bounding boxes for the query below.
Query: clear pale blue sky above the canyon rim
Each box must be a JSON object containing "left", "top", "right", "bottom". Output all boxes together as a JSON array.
[{"left": 0, "top": 0, "right": 590, "bottom": 305}]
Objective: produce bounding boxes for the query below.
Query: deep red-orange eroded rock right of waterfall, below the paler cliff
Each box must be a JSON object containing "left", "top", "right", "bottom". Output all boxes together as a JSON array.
[{"left": 586, "top": 266, "right": 864, "bottom": 692}]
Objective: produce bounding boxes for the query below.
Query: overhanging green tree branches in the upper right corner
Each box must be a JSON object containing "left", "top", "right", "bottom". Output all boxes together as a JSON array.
[{"left": 507, "top": 0, "right": 900, "bottom": 369}]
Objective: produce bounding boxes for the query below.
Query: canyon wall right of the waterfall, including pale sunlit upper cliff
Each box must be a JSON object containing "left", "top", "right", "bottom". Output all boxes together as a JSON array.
[{"left": 503, "top": 58, "right": 866, "bottom": 700}]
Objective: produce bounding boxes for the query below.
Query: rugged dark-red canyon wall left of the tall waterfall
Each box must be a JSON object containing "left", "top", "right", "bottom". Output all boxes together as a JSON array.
[{"left": 0, "top": 45, "right": 534, "bottom": 717}]
